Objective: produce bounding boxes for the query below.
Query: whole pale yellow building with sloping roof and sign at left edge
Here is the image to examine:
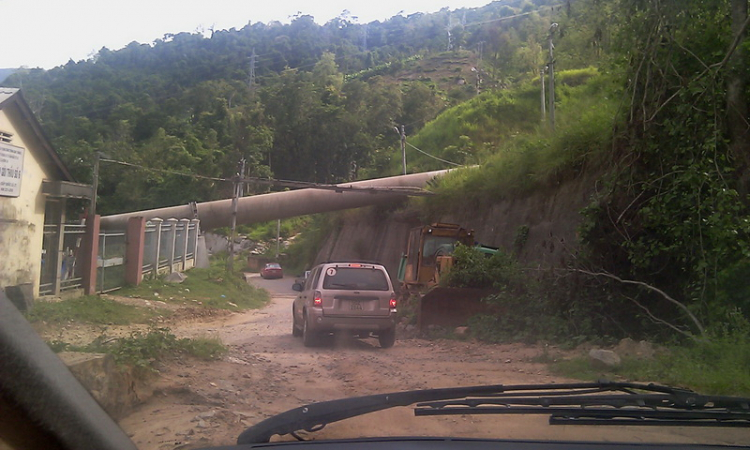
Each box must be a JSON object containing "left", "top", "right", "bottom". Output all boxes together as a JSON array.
[{"left": 0, "top": 87, "right": 91, "bottom": 304}]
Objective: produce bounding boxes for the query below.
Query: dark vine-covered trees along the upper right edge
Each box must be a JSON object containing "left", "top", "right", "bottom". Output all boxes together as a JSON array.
[{"left": 590, "top": 0, "right": 750, "bottom": 320}]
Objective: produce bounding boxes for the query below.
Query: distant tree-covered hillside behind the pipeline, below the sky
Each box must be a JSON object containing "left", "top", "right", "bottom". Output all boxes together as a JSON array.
[{"left": 5, "top": 0, "right": 576, "bottom": 214}]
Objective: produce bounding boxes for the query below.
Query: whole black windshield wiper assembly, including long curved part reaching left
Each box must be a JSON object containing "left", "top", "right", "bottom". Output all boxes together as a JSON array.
[{"left": 237, "top": 381, "right": 750, "bottom": 444}]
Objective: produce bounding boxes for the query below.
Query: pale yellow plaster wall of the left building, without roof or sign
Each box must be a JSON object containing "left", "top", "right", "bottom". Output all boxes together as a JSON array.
[{"left": 0, "top": 104, "right": 51, "bottom": 297}]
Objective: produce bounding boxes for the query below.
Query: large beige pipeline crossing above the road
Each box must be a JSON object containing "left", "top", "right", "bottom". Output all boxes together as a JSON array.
[{"left": 101, "top": 170, "right": 448, "bottom": 230}]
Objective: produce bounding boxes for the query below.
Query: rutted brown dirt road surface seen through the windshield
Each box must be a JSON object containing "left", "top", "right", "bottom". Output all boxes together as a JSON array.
[{"left": 120, "top": 276, "right": 748, "bottom": 450}]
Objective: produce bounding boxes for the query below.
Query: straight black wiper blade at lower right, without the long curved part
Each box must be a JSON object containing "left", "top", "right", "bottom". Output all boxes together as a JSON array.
[{"left": 414, "top": 382, "right": 750, "bottom": 427}]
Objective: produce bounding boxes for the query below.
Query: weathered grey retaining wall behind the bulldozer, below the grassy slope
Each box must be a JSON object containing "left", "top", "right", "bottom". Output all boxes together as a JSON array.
[{"left": 316, "top": 174, "right": 599, "bottom": 278}]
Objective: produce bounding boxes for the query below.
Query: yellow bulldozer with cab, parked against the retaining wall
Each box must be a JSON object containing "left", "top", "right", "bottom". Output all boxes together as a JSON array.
[{"left": 398, "top": 223, "right": 497, "bottom": 331}]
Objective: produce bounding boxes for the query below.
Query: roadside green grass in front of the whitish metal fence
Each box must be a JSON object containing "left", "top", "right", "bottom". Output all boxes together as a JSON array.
[{"left": 119, "top": 259, "right": 271, "bottom": 311}]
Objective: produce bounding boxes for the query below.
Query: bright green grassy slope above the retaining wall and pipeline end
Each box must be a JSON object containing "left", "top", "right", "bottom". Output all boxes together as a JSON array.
[{"left": 418, "top": 69, "right": 620, "bottom": 217}]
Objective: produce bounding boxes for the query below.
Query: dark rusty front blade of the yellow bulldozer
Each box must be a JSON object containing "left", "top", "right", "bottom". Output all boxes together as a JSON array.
[{"left": 417, "top": 287, "right": 494, "bottom": 332}]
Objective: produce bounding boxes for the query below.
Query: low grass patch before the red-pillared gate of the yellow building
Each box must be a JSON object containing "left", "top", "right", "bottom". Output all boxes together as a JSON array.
[{"left": 26, "top": 295, "right": 158, "bottom": 325}]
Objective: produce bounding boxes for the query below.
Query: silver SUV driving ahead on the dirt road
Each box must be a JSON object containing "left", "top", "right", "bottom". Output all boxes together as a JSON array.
[{"left": 292, "top": 262, "right": 396, "bottom": 348}]
